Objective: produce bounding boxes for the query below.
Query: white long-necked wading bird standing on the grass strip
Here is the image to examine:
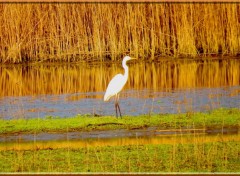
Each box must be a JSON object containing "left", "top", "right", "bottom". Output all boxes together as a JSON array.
[{"left": 104, "top": 56, "right": 136, "bottom": 117}]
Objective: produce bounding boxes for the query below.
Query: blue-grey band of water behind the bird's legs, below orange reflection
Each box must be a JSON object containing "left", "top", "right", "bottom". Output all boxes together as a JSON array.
[{"left": 0, "top": 86, "right": 240, "bottom": 119}]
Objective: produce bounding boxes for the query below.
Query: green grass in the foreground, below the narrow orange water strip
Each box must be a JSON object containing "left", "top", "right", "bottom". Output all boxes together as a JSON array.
[{"left": 0, "top": 141, "right": 240, "bottom": 172}]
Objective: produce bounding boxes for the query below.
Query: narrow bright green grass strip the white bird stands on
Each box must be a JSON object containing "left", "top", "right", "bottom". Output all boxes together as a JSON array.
[{"left": 0, "top": 109, "right": 240, "bottom": 134}]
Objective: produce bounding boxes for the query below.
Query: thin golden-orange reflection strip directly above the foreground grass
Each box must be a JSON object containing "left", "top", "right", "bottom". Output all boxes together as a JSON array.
[{"left": 0, "top": 134, "right": 240, "bottom": 151}]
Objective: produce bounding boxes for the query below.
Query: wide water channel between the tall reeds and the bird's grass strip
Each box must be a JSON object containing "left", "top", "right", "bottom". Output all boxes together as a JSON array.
[{"left": 0, "top": 59, "right": 240, "bottom": 118}]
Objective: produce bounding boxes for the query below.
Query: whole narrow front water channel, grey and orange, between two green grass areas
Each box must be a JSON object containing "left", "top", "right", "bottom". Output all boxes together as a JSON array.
[{"left": 0, "top": 127, "right": 240, "bottom": 151}]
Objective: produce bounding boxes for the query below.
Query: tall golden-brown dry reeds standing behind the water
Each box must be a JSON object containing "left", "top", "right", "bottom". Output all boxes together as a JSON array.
[{"left": 0, "top": 3, "right": 240, "bottom": 63}]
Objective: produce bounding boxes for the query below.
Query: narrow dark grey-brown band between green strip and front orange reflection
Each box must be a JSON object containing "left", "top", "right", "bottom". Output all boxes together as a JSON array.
[{"left": 0, "top": 127, "right": 240, "bottom": 143}]
